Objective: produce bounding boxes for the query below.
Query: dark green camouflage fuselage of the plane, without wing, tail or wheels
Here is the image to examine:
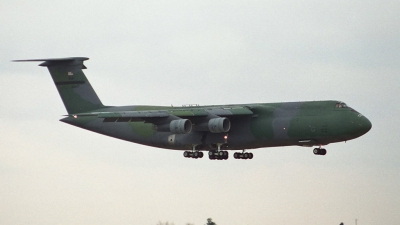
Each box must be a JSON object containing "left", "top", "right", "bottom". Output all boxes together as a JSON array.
[{"left": 61, "top": 101, "right": 371, "bottom": 150}]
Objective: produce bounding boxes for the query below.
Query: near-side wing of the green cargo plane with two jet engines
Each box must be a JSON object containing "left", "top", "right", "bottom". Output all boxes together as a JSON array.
[{"left": 69, "top": 106, "right": 253, "bottom": 134}]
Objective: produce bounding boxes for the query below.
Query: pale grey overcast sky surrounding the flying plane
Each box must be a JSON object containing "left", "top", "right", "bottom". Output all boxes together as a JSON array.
[{"left": 0, "top": 0, "right": 400, "bottom": 225}]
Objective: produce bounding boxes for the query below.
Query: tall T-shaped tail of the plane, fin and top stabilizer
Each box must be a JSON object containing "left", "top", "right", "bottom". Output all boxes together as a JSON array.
[{"left": 14, "top": 57, "right": 104, "bottom": 114}]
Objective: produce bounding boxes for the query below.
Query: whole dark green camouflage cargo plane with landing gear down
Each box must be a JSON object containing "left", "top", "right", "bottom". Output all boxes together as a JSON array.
[{"left": 15, "top": 57, "right": 372, "bottom": 160}]
